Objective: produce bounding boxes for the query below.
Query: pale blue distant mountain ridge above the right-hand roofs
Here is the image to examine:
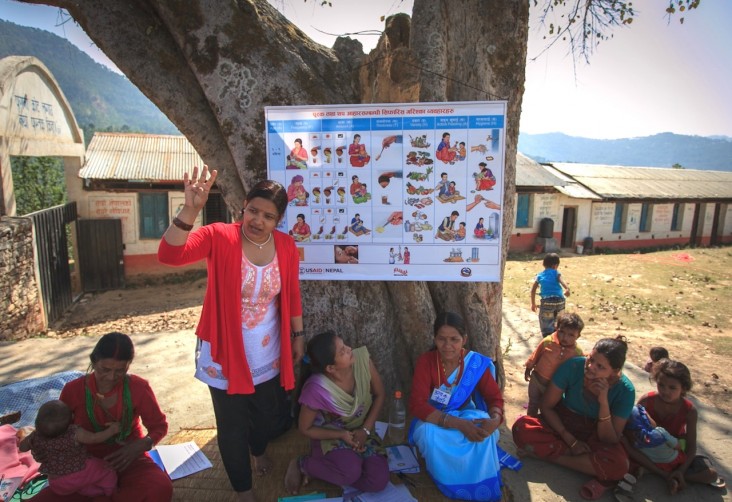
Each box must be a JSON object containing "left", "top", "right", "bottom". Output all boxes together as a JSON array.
[{"left": 518, "top": 132, "right": 732, "bottom": 171}]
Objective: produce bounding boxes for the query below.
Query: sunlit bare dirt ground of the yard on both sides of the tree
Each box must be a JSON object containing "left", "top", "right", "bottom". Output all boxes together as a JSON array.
[{"left": 0, "top": 250, "right": 732, "bottom": 502}]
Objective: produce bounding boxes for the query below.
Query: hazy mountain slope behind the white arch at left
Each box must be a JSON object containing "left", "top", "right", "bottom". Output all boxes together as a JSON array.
[{"left": 0, "top": 19, "right": 180, "bottom": 140}]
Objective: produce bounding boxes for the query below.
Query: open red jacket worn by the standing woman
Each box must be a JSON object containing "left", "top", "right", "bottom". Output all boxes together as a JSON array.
[{"left": 158, "top": 223, "right": 302, "bottom": 394}]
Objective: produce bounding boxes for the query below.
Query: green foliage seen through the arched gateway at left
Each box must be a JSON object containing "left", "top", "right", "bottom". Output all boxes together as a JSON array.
[{"left": 10, "top": 157, "right": 66, "bottom": 216}]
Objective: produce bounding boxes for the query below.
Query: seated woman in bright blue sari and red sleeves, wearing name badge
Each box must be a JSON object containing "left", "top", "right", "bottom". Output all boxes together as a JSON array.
[{"left": 409, "top": 312, "right": 505, "bottom": 501}]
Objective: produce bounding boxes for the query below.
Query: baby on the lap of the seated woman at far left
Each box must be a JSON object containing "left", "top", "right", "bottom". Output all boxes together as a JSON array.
[{"left": 18, "top": 401, "right": 120, "bottom": 497}]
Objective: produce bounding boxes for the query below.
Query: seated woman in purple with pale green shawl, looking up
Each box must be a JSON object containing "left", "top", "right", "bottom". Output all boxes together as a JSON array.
[{"left": 285, "top": 332, "right": 389, "bottom": 494}]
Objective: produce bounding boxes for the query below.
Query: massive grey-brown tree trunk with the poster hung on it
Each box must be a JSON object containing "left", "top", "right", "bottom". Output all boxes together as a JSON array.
[{"left": 25, "top": 0, "right": 529, "bottom": 396}]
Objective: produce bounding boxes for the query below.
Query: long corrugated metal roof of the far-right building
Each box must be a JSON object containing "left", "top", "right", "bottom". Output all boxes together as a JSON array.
[{"left": 551, "top": 162, "right": 732, "bottom": 200}]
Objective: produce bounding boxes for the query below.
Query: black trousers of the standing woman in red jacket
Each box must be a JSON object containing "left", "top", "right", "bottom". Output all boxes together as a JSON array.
[{"left": 209, "top": 375, "right": 292, "bottom": 492}]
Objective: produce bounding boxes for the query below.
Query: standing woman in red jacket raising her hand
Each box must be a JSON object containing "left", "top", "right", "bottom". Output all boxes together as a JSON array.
[{"left": 158, "top": 166, "right": 305, "bottom": 500}]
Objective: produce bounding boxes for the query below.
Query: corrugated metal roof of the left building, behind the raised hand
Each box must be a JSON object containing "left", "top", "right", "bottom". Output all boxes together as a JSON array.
[{"left": 79, "top": 132, "right": 203, "bottom": 182}]
